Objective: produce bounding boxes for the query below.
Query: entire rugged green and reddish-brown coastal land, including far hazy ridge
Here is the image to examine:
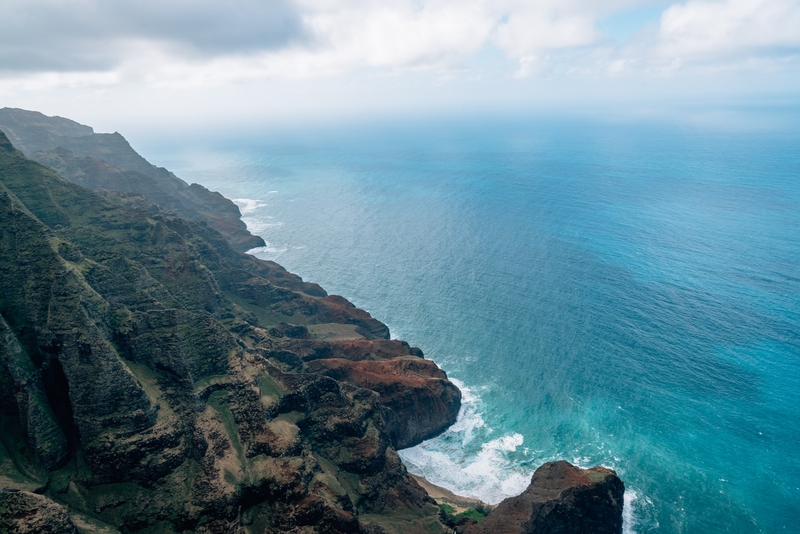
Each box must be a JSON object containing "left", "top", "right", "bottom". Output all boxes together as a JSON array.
[{"left": 0, "top": 109, "right": 623, "bottom": 533}]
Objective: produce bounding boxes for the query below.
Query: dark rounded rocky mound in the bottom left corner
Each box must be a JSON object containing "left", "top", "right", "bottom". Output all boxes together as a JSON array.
[{"left": 0, "top": 490, "right": 78, "bottom": 534}]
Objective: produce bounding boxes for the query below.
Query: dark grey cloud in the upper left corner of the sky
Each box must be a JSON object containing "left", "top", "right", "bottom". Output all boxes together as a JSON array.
[{"left": 0, "top": 0, "right": 303, "bottom": 71}]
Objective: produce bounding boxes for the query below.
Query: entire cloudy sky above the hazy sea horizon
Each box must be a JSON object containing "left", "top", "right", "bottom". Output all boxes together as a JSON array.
[{"left": 0, "top": 0, "right": 800, "bottom": 131}]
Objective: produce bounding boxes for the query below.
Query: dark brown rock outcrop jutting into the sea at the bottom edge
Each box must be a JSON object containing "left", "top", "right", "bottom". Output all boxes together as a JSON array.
[{"left": 459, "top": 461, "right": 625, "bottom": 534}]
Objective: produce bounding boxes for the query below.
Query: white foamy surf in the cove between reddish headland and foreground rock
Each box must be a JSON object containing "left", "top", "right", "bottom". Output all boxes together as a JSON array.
[{"left": 400, "top": 379, "right": 531, "bottom": 504}]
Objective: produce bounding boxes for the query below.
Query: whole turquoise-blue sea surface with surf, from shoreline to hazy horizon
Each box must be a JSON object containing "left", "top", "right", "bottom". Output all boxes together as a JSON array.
[{"left": 142, "top": 118, "right": 800, "bottom": 534}]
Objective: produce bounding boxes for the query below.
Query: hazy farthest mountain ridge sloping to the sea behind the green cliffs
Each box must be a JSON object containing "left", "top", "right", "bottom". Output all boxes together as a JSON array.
[{"left": 0, "top": 108, "right": 265, "bottom": 251}]
